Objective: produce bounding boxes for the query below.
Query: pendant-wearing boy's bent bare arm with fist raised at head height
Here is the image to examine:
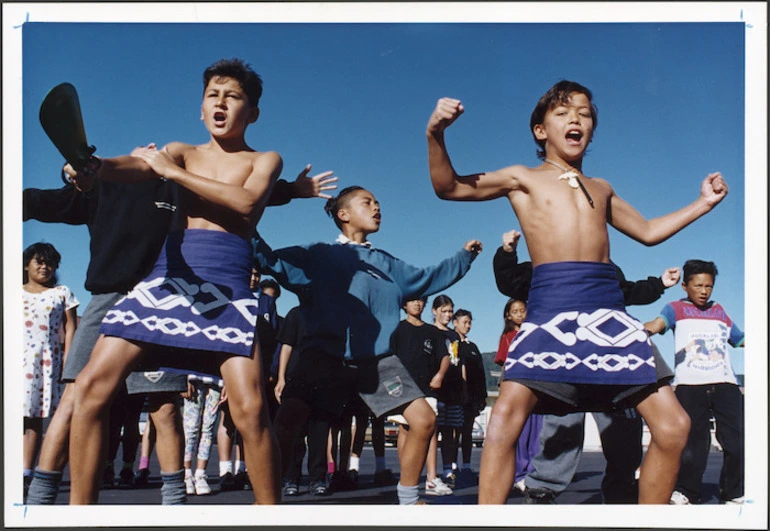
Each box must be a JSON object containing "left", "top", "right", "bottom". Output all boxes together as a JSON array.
[{"left": 426, "top": 98, "right": 516, "bottom": 201}]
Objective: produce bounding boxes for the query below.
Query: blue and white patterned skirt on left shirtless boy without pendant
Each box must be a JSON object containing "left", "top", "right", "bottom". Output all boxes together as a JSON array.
[{"left": 100, "top": 229, "right": 258, "bottom": 356}]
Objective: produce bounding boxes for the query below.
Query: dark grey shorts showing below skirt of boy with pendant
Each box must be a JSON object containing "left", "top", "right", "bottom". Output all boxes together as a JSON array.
[{"left": 510, "top": 343, "right": 674, "bottom": 415}]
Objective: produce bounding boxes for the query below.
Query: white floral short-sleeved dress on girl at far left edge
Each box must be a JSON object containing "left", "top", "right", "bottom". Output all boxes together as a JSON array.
[{"left": 23, "top": 286, "right": 79, "bottom": 418}]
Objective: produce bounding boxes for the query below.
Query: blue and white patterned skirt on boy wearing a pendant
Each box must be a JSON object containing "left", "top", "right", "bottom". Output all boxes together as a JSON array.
[{"left": 504, "top": 262, "right": 657, "bottom": 385}]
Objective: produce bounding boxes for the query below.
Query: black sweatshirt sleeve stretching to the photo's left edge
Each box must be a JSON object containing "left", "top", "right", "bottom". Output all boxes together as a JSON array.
[{"left": 22, "top": 183, "right": 98, "bottom": 225}]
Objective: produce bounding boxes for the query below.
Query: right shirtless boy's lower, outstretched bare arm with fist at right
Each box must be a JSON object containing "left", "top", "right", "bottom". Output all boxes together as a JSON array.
[{"left": 607, "top": 173, "right": 727, "bottom": 245}]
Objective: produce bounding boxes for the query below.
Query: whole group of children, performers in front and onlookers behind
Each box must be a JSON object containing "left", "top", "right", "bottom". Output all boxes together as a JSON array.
[{"left": 24, "top": 56, "right": 744, "bottom": 505}]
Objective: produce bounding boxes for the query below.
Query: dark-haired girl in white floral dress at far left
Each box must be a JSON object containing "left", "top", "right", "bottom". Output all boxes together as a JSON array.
[{"left": 23, "top": 243, "right": 78, "bottom": 491}]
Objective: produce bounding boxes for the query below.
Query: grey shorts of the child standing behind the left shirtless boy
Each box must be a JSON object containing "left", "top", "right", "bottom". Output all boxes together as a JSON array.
[{"left": 62, "top": 293, "right": 187, "bottom": 394}]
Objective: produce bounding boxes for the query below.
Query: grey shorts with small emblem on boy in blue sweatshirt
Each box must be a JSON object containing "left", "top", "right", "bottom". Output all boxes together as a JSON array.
[{"left": 351, "top": 356, "right": 425, "bottom": 417}]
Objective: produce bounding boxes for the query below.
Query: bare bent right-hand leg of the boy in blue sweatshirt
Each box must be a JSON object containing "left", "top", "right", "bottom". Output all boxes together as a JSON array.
[{"left": 399, "top": 398, "right": 436, "bottom": 487}]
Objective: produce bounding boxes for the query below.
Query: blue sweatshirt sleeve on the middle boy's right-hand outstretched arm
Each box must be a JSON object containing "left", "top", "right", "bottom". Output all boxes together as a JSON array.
[{"left": 396, "top": 249, "right": 476, "bottom": 299}]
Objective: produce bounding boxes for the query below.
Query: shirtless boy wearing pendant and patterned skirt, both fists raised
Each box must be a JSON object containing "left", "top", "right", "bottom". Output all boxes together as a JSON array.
[{"left": 426, "top": 81, "right": 727, "bottom": 504}]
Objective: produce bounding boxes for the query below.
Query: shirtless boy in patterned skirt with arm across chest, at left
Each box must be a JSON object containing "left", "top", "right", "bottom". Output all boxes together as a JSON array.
[{"left": 65, "top": 59, "right": 282, "bottom": 504}]
